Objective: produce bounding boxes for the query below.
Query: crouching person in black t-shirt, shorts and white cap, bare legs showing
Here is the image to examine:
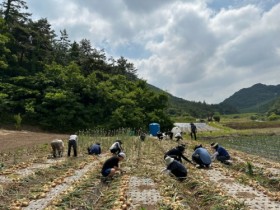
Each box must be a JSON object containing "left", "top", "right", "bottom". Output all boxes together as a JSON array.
[{"left": 101, "top": 152, "right": 126, "bottom": 180}]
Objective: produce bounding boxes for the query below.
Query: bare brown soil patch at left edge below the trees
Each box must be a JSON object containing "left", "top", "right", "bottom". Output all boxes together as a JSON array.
[{"left": 0, "top": 129, "right": 69, "bottom": 152}]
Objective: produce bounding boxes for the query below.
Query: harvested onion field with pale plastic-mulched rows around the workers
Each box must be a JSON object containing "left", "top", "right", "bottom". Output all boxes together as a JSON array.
[{"left": 0, "top": 127, "right": 280, "bottom": 210}]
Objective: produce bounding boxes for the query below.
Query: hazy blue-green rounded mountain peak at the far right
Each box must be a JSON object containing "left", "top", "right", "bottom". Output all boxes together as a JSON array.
[{"left": 221, "top": 83, "right": 280, "bottom": 112}]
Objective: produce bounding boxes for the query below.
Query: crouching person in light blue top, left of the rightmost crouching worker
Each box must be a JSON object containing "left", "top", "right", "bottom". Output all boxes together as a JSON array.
[{"left": 192, "top": 144, "right": 212, "bottom": 168}]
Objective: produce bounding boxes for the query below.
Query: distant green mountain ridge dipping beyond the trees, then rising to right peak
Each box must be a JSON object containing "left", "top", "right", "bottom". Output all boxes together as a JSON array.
[{"left": 151, "top": 83, "right": 280, "bottom": 117}]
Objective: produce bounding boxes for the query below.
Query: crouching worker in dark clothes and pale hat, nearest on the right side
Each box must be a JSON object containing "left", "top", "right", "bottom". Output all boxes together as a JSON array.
[{"left": 164, "top": 156, "right": 187, "bottom": 181}]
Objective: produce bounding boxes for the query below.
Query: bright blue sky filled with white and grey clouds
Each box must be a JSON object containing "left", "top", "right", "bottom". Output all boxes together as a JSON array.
[{"left": 19, "top": 0, "right": 280, "bottom": 104}]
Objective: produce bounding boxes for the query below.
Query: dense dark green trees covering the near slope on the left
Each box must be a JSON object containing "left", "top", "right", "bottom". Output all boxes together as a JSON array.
[{"left": 0, "top": 0, "right": 173, "bottom": 131}]
